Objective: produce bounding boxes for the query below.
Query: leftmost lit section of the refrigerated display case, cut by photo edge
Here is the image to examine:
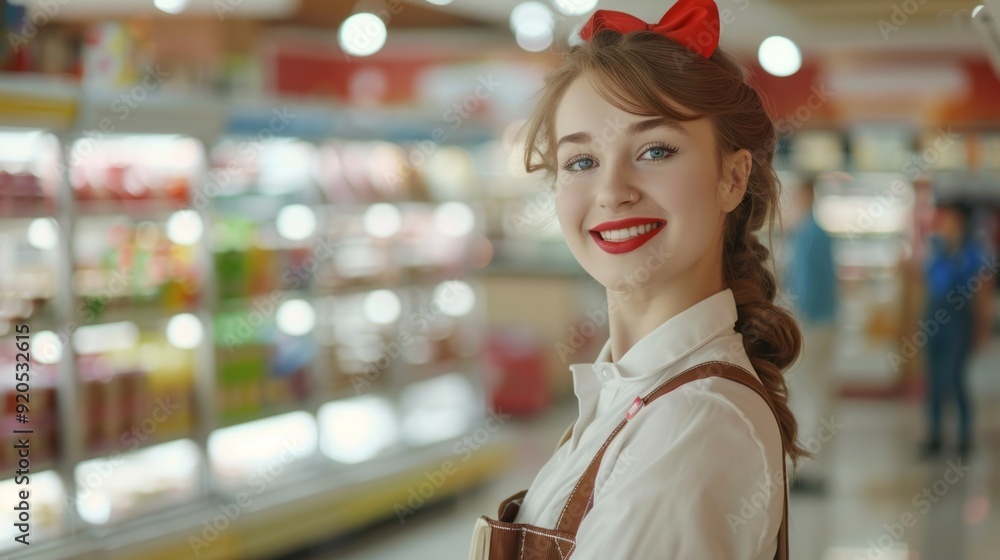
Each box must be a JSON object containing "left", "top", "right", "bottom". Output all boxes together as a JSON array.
[{"left": 0, "top": 127, "right": 70, "bottom": 552}]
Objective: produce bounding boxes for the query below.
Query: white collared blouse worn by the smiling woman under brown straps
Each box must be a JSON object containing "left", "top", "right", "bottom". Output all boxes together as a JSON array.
[{"left": 516, "top": 288, "right": 785, "bottom": 560}]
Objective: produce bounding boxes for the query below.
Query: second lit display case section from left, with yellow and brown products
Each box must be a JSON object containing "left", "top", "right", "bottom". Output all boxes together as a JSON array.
[{"left": 67, "top": 134, "right": 210, "bottom": 527}]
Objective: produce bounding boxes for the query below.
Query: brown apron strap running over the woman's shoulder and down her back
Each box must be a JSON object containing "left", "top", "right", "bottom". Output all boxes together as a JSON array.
[{"left": 556, "top": 362, "right": 788, "bottom": 560}]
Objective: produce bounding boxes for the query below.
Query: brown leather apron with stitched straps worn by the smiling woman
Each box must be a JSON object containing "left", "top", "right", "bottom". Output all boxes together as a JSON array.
[{"left": 469, "top": 362, "right": 788, "bottom": 560}]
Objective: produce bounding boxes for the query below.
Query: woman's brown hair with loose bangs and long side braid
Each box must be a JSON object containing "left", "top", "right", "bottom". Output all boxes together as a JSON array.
[{"left": 524, "top": 30, "right": 810, "bottom": 461}]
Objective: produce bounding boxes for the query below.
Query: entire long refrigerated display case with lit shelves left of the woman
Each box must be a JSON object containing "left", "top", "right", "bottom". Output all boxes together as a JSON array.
[{"left": 0, "top": 106, "right": 508, "bottom": 559}]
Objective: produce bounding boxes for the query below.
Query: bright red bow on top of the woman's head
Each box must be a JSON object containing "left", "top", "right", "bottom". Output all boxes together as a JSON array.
[{"left": 580, "top": 0, "right": 719, "bottom": 58}]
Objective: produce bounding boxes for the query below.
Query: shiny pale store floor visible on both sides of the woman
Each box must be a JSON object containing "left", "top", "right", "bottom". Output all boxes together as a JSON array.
[{"left": 295, "top": 341, "right": 1000, "bottom": 560}]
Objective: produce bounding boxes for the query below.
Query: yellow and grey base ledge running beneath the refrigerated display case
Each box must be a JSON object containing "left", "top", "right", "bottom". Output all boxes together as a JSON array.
[{"left": 6, "top": 435, "right": 512, "bottom": 560}]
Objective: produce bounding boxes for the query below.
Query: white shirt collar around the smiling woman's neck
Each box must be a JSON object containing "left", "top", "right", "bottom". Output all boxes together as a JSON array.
[{"left": 570, "top": 288, "right": 738, "bottom": 388}]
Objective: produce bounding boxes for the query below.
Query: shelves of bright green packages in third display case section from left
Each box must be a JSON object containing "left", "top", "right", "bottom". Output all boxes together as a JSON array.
[{"left": 208, "top": 138, "right": 317, "bottom": 426}]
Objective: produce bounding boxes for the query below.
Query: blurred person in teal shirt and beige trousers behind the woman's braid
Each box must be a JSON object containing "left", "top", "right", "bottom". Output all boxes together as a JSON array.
[{"left": 785, "top": 177, "right": 838, "bottom": 494}]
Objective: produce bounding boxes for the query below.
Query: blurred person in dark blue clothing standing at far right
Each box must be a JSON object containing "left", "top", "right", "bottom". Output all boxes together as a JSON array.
[{"left": 921, "top": 201, "right": 996, "bottom": 457}]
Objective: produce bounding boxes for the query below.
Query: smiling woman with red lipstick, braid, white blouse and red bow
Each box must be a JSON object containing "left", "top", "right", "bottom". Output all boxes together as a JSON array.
[{"left": 471, "top": 0, "right": 805, "bottom": 560}]
